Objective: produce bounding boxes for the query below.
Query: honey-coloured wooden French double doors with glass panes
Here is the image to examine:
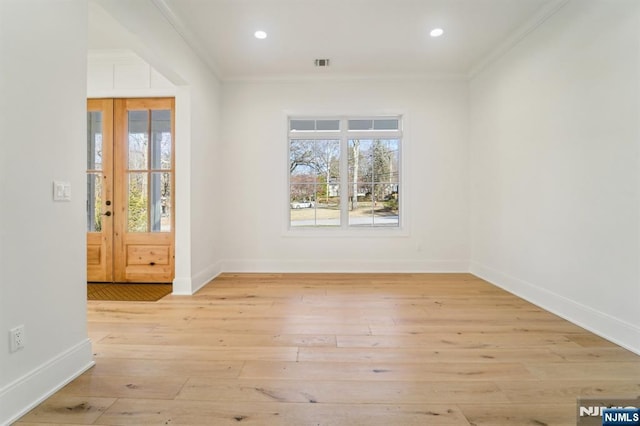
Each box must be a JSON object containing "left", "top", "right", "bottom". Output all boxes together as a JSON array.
[{"left": 87, "top": 98, "right": 175, "bottom": 283}]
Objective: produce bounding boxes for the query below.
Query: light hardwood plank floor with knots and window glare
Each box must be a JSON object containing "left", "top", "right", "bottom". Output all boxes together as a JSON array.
[{"left": 17, "top": 274, "right": 640, "bottom": 426}]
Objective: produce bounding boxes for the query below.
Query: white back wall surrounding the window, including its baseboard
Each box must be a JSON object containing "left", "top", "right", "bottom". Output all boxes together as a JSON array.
[{"left": 221, "top": 79, "right": 469, "bottom": 272}]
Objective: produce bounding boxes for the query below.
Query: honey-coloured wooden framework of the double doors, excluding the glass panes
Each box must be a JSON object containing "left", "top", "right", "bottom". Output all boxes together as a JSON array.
[{"left": 86, "top": 96, "right": 176, "bottom": 283}]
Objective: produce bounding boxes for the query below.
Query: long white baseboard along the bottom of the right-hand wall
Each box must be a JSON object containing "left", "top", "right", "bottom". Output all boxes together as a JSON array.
[{"left": 469, "top": 262, "right": 640, "bottom": 355}]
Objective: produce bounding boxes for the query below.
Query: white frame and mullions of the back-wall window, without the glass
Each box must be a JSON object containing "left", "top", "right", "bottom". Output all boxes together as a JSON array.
[{"left": 285, "top": 114, "right": 408, "bottom": 236}]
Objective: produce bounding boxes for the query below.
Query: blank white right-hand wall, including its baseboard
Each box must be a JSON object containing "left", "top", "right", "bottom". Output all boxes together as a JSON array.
[{"left": 470, "top": 0, "right": 640, "bottom": 353}]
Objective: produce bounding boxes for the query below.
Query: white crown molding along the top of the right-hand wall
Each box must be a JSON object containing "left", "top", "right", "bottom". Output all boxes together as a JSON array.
[{"left": 467, "top": 0, "right": 569, "bottom": 80}]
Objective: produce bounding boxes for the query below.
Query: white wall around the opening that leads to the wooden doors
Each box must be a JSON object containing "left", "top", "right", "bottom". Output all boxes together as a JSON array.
[{"left": 90, "top": 0, "right": 224, "bottom": 294}]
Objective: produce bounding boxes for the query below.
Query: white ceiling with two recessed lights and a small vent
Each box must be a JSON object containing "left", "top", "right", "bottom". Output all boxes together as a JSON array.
[{"left": 91, "top": 0, "right": 566, "bottom": 80}]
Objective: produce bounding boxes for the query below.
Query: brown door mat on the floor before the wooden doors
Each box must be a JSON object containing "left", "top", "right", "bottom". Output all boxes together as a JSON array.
[{"left": 87, "top": 283, "right": 173, "bottom": 302}]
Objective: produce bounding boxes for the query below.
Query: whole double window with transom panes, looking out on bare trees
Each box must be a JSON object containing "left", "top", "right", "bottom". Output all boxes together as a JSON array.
[{"left": 288, "top": 117, "right": 402, "bottom": 228}]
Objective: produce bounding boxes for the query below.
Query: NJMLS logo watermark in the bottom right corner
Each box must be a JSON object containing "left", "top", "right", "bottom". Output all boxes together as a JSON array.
[{"left": 577, "top": 396, "right": 640, "bottom": 426}]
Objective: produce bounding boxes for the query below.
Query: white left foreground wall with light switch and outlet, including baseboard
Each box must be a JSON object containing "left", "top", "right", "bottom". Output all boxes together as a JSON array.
[{"left": 0, "top": 0, "right": 92, "bottom": 424}]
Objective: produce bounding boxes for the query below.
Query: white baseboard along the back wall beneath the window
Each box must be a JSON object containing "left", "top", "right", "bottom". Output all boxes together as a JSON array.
[{"left": 223, "top": 260, "right": 469, "bottom": 273}]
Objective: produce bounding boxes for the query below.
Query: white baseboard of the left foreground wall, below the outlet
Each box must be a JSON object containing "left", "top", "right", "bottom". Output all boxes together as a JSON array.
[{"left": 0, "top": 339, "right": 94, "bottom": 425}]
